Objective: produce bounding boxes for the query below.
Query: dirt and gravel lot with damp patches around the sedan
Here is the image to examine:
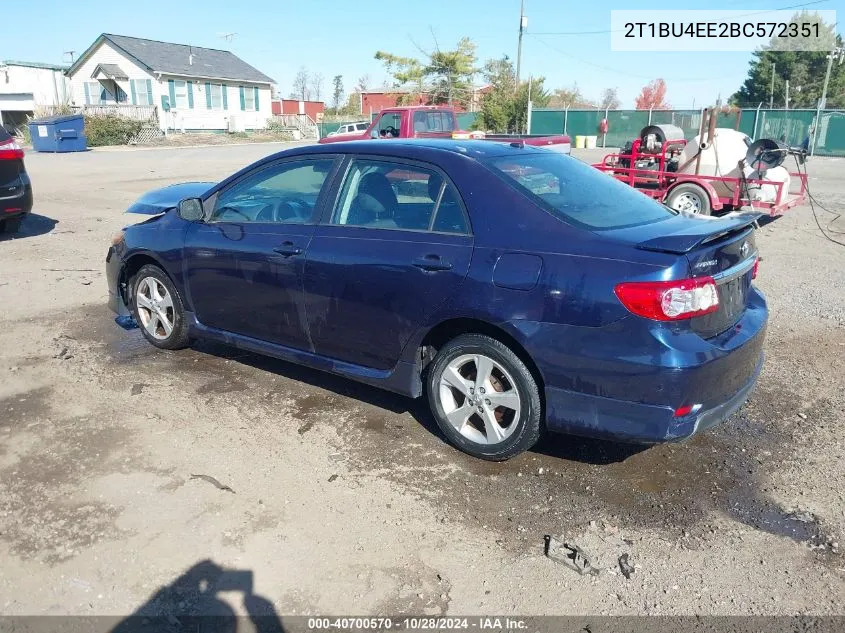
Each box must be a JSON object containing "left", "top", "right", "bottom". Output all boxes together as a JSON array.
[{"left": 0, "top": 145, "right": 845, "bottom": 615}]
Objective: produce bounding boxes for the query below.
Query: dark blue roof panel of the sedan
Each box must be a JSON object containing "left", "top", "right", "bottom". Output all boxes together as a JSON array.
[{"left": 282, "top": 138, "right": 544, "bottom": 160}]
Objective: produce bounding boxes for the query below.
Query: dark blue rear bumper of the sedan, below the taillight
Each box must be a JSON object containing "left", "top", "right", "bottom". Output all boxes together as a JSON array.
[{"left": 513, "top": 286, "right": 768, "bottom": 443}]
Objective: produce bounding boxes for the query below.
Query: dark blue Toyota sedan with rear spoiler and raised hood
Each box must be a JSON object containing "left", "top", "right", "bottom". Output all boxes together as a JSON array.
[{"left": 107, "top": 140, "right": 767, "bottom": 460}]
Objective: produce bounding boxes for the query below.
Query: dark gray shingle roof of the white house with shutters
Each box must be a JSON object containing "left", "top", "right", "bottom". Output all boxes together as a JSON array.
[{"left": 80, "top": 33, "right": 274, "bottom": 83}]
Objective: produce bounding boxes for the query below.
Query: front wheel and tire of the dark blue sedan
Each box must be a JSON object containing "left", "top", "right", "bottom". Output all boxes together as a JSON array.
[{"left": 129, "top": 264, "right": 190, "bottom": 349}]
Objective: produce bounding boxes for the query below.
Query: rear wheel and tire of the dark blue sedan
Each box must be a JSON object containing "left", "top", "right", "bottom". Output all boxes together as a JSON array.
[{"left": 426, "top": 334, "right": 543, "bottom": 461}]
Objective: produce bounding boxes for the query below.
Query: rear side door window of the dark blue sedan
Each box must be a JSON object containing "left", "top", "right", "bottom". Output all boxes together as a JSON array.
[{"left": 331, "top": 159, "right": 468, "bottom": 234}]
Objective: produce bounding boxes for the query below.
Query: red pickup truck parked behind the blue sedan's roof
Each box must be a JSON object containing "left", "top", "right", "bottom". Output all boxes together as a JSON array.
[{"left": 320, "top": 106, "right": 572, "bottom": 154}]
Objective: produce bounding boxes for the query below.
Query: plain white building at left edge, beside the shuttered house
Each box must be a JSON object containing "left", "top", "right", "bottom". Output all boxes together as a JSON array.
[{"left": 0, "top": 60, "right": 70, "bottom": 131}]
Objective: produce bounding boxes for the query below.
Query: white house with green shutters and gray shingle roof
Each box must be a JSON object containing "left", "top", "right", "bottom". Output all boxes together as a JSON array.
[{"left": 67, "top": 33, "right": 274, "bottom": 132}]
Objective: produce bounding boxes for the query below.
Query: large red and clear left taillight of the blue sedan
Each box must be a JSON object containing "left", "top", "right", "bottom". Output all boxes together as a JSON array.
[{"left": 614, "top": 277, "right": 719, "bottom": 321}]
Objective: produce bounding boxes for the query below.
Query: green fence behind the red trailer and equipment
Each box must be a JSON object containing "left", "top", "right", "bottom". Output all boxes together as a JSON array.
[{"left": 528, "top": 109, "right": 845, "bottom": 156}]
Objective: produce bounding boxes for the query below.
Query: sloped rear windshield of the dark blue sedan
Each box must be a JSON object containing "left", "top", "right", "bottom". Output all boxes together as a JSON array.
[{"left": 489, "top": 151, "right": 675, "bottom": 230}]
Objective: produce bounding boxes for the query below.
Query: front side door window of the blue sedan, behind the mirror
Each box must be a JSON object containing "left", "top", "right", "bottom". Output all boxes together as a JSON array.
[{"left": 209, "top": 158, "right": 334, "bottom": 224}]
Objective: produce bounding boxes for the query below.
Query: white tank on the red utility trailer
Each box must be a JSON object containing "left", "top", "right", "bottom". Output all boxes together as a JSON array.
[{"left": 678, "top": 127, "right": 751, "bottom": 196}]
